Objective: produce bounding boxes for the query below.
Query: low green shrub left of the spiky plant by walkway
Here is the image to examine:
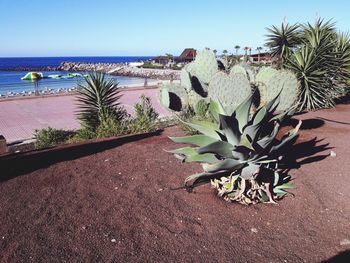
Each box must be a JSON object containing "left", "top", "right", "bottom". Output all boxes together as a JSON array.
[{"left": 34, "top": 127, "right": 74, "bottom": 149}]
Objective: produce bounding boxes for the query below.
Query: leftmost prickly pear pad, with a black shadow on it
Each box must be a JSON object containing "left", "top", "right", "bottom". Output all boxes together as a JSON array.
[{"left": 158, "top": 83, "right": 188, "bottom": 111}]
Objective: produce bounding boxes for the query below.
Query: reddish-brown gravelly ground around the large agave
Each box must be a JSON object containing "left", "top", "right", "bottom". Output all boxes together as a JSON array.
[{"left": 0, "top": 105, "right": 350, "bottom": 262}]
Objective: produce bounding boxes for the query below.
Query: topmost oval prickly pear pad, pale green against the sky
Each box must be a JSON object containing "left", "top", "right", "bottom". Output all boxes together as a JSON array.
[{"left": 194, "top": 49, "right": 218, "bottom": 84}]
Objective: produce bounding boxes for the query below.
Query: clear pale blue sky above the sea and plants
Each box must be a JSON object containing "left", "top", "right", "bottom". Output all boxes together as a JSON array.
[{"left": 0, "top": 0, "right": 350, "bottom": 57}]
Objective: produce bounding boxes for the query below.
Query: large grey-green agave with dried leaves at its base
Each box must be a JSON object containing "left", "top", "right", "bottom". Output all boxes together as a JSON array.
[{"left": 170, "top": 94, "right": 301, "bottom": 204}]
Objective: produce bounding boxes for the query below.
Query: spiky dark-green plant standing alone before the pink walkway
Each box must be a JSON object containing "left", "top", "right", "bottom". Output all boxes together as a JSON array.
[{"left": 77, "top": 72, "right": 126, "bottom": 131}]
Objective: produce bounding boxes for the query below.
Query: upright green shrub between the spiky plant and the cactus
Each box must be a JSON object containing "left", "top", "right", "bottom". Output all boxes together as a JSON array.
[{"left": 129, "top": 95, "right": 159, "bottom": 133}]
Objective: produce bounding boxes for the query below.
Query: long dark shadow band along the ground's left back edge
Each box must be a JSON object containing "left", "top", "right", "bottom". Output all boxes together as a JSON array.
[{"left": 0, "top": 130, "right": 162, "bottom": 182}]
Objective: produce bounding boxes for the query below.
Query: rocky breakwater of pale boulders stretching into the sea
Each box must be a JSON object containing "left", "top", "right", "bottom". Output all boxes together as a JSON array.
[{"left": 57, "top": 62, "right": 180, "bottom": 80}]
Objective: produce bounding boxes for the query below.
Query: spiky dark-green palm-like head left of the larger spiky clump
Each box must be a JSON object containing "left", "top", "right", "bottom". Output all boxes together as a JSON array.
[{"left": 266, "top": 23, "right": 301, "bottom": 66}]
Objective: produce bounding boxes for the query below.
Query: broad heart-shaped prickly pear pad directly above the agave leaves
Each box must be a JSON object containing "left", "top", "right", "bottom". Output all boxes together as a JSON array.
[{"left": 208, "top": 72, "right": 251, "bottom": 113}]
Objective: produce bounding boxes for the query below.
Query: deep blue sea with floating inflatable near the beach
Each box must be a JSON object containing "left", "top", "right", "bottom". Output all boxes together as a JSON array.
[{"left": 0, "top": 57, "right": 152, "bottom": 95}]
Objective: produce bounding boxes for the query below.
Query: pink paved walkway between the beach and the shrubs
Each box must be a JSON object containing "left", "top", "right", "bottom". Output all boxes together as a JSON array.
[{"left": 0, "top": 88, "right": 169, "bottom": 142}]
